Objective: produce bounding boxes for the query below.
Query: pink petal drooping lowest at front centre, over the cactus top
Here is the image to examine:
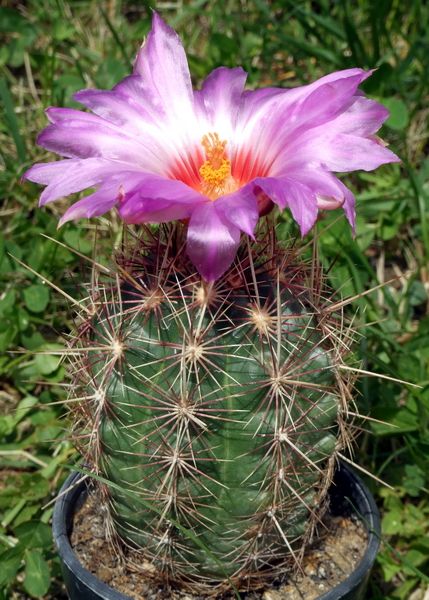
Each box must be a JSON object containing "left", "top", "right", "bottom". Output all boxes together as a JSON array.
[{"left": 187, "top": 202, "right": 240, "bottom": 281}]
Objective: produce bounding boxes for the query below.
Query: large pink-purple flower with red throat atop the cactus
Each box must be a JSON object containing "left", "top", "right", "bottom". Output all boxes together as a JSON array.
[{"left": 25, "top": 13, "right": 398, "bottom": 280}]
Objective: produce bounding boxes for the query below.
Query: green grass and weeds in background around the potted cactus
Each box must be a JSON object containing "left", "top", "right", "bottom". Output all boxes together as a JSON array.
[{"left": 0, "top": 0, "right": 429, "bottom": 600}]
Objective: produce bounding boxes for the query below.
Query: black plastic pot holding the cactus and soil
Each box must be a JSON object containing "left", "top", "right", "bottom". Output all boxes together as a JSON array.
[{"left": 52, "top": 464, "right": 380, "bottom": 600}]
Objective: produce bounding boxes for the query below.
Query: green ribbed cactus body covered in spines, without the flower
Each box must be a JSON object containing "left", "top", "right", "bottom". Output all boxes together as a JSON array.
[{"left": 71, "top": 224, "right": 350, "bottom": 590}]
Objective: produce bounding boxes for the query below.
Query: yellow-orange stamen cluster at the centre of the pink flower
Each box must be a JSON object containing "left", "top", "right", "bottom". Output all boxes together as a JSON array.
[{"left": 199, "top": 133, "right": 232, "bottom": 200}]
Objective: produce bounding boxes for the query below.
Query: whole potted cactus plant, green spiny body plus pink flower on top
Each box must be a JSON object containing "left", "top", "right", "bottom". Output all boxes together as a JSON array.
[{"left": 25, "top": 14, "right": 397, "bottom": 590}]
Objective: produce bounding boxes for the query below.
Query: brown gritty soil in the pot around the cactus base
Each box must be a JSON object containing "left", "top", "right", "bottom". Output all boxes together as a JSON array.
[{"left": 71, "top": 494, "right": 367, "bottom": 600}]
